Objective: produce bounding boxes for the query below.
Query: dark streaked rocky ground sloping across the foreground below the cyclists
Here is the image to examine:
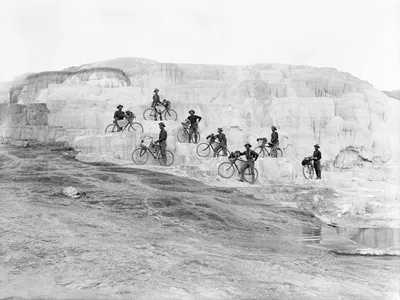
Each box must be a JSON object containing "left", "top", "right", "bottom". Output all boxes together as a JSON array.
[{"left": 0, "top": 146, "right": 400, "bottom": 300}]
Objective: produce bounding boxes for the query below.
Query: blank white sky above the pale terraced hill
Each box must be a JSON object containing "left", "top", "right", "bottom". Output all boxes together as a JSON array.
[{"left": 0, "top": 0, "right": 400, "bottom": 90}]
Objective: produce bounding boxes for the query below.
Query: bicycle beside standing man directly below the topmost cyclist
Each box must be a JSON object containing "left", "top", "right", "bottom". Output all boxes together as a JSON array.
[{"left": 132, "top": 137, "right": 174, "bottom": 166}]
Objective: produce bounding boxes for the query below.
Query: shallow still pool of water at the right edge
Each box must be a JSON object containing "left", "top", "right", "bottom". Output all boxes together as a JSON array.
[{"left": 299, "top": 227, "right": 400, "bottom": 255}]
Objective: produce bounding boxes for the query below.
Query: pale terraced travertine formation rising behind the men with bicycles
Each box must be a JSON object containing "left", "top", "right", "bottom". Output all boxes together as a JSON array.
[{"left": 0, "top": 58, "right": 400, "bottom": 172}]
